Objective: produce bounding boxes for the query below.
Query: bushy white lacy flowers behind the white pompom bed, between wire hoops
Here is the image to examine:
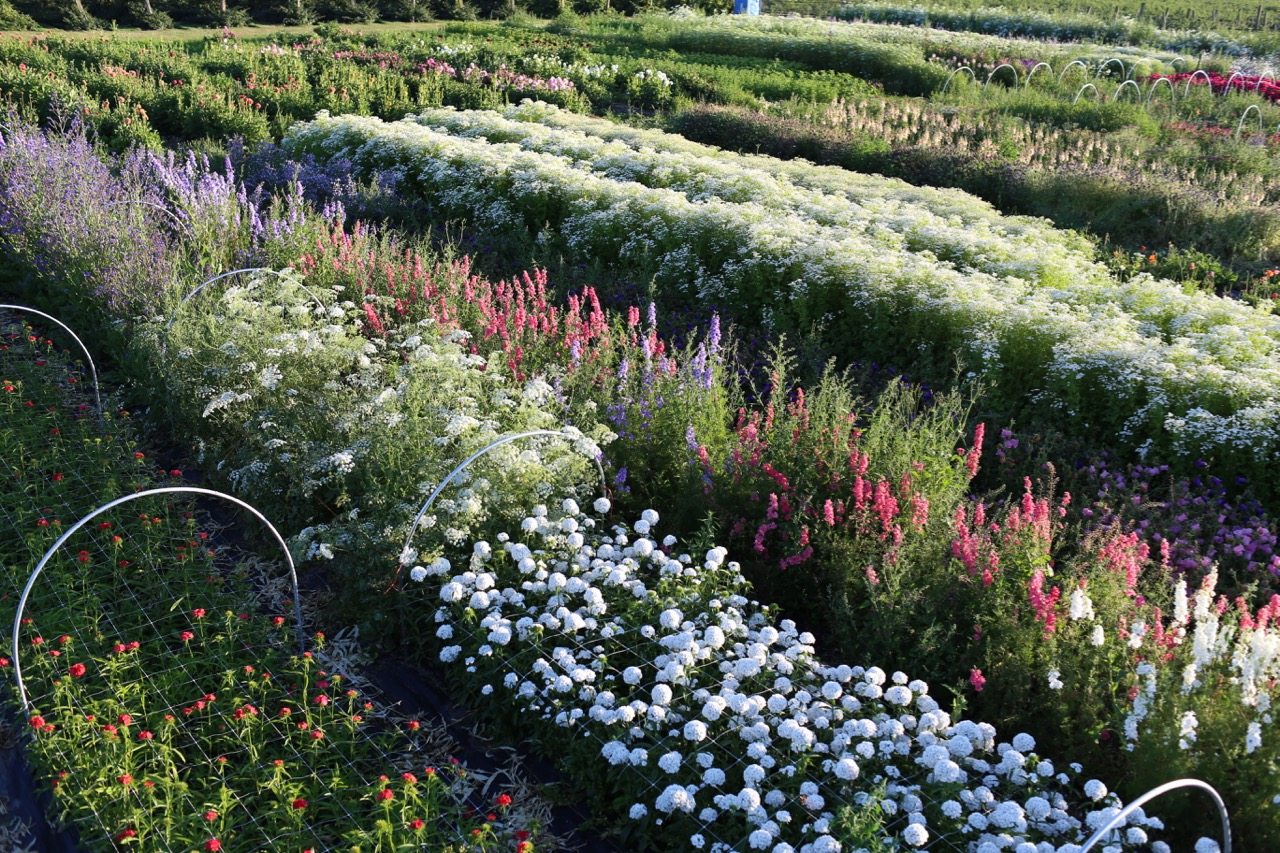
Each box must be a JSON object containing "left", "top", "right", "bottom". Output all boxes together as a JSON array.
[{"left": 165, "top": 274, "right": 613, "bottom": 565}]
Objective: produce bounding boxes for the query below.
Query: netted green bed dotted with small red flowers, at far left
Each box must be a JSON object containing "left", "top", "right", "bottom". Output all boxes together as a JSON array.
[{"left": 0, "top": 320, "right": 537, "bottom": 850}]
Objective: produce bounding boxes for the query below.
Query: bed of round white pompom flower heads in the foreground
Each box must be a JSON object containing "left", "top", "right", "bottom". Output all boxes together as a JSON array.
[{"left": 424, "top": 498, "right": 1167, "bottom": 853}]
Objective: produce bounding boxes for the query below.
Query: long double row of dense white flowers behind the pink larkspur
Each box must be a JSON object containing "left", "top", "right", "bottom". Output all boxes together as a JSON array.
[{"left": 285, "top": 105, "right": 1280, "bottom": 461}]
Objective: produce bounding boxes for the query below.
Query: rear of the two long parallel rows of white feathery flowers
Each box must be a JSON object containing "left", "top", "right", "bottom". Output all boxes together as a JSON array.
[{"left": 410, "top": 100, "right": 1106, "bottom": 284}]
